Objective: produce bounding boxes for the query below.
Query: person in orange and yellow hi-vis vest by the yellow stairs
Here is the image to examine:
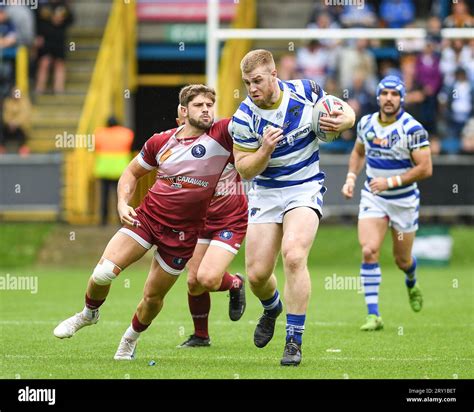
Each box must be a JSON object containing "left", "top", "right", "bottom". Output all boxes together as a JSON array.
[{"left": 94, "top": 116, "right": 133, "bottom": 225}]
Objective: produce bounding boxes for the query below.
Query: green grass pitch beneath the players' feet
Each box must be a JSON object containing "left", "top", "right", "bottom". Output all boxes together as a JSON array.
[{"left": 0, "top": 224, "right": 474, "bottom": 379}]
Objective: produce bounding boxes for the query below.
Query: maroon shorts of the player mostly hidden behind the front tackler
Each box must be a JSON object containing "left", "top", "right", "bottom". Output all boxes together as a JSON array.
[{"left": 198, "top": 223, "right": 247, "bottom": 255}]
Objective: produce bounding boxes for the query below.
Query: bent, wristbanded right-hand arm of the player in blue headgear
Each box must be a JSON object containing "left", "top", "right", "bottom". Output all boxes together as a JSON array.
[{"left": 369, "top": 146, "right": 433, "bottom": 193}]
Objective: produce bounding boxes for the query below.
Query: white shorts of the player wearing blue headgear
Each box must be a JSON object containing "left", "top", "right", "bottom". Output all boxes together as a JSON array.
[{"left": 359, "top": 190, "right": 420, "bottom": 233}]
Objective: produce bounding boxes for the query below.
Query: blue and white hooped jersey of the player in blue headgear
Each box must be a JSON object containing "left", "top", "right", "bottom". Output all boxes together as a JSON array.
[{"left": 357, "top": 110, "right": 429, "bottom": 199}]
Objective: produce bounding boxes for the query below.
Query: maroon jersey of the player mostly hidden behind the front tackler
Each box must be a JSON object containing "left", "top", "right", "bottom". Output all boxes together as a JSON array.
[{"left": 206, "top": 156, "right": 248, "bottom": 230}]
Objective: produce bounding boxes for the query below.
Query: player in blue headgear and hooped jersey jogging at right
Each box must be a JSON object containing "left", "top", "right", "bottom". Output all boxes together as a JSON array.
[{"left": 342, "top": 76, "right": 433, "bottom": 331}]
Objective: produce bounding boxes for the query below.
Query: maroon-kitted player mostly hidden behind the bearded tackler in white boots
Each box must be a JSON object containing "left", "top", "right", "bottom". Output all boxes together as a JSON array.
[{"left": 176, "top": 106, "right": 247, "bottom": 348}]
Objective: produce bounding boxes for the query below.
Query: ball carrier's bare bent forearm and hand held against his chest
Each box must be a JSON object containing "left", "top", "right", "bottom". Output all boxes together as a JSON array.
[{"left": 234, "top": 126, "right": 283, "bottom": 180}]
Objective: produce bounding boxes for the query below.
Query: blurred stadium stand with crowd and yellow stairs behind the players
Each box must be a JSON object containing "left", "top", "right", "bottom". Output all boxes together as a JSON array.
[{"left": 0, "top": 0, "right": 474, "bottom": 264}]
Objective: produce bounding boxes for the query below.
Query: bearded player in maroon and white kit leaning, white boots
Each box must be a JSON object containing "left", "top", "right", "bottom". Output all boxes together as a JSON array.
[{"left": 54, "top": 85, "right": 237, "bottom": 360}]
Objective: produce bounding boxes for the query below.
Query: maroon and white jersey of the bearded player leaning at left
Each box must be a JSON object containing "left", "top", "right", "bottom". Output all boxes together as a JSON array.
[{"left": 136, "top": 119, "right": 232, "bottom": 230}]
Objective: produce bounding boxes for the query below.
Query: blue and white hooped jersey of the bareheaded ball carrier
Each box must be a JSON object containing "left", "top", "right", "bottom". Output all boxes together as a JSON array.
[{"left": 231, "top": 80, "right": 325, "bottom": 188}]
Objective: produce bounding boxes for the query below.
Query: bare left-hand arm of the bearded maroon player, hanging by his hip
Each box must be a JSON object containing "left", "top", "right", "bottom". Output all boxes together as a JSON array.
[{"left": 117, "top": 158, "right": 151, "bottom": 226}]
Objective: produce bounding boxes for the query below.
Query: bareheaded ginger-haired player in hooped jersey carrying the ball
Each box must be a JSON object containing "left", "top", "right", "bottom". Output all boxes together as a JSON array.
[{"left": 232, "top": 50, "right": 355, "bottom": 366}]
